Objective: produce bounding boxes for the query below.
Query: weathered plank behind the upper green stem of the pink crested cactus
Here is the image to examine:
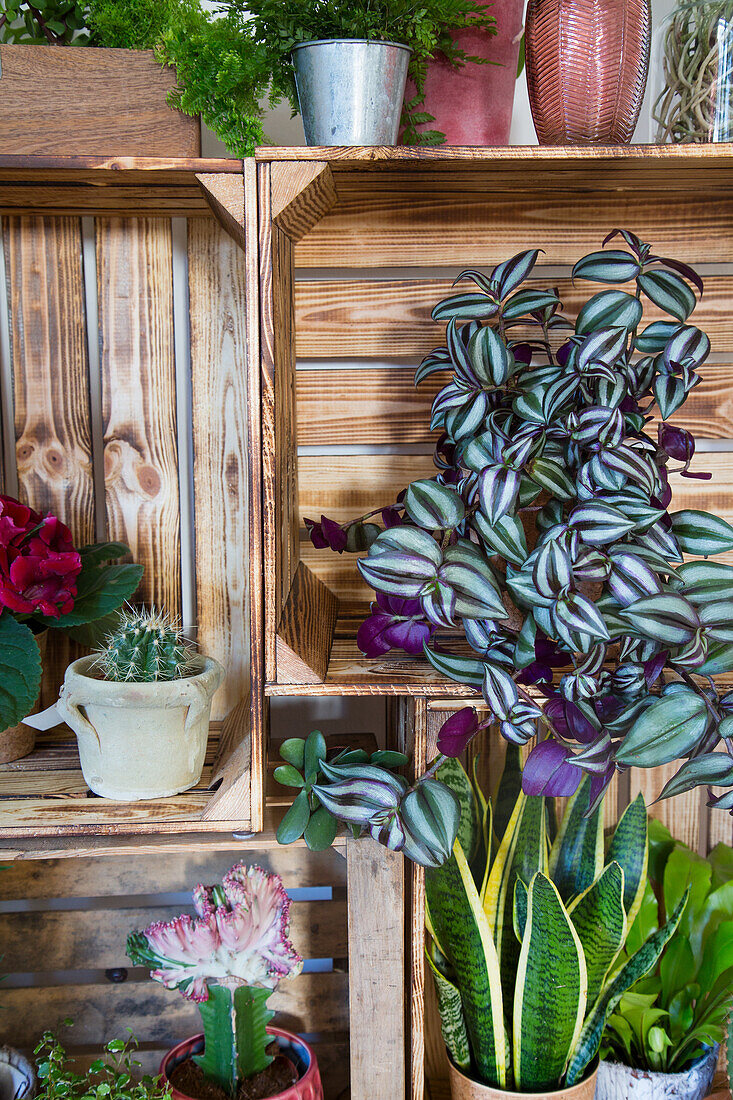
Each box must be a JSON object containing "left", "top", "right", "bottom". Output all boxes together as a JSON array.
[{"left": 3, "top": 972, "right": 347, "bottom": 1042}]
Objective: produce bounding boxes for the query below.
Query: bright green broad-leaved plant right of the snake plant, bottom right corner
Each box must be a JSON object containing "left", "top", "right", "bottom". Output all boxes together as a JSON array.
[{"left": 602, "top": 821, "right": 733, "bottom": 1074}]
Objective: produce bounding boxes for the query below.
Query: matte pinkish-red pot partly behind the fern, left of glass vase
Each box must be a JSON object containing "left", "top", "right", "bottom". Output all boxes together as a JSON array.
[{"left": 406, "top": 0, "right": 524, "bottom": 145}]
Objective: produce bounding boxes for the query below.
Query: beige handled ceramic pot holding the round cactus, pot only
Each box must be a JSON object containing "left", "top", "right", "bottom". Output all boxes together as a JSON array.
[{"left": 58, "top": 657, "right": 225, "bottom": 802}]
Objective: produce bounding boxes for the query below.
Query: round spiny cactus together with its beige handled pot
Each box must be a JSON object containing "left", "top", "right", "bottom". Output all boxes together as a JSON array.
[{"left": 58, "top": 608, "right": 223, "bottom": 801}]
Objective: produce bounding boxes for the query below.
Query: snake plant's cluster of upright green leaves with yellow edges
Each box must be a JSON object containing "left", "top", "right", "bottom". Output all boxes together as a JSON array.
[{"left": 426, "top": 746, "right": 687, "bottom": 1092}]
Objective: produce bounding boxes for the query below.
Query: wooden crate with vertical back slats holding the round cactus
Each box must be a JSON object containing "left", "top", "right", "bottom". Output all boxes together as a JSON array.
[{"left": 0, "top": 157, "right": 263, "bottom": 853}]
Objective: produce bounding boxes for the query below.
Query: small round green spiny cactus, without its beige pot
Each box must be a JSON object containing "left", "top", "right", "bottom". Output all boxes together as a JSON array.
[{"left": 98, "top": 608, "right": 194, "bottom": 683}]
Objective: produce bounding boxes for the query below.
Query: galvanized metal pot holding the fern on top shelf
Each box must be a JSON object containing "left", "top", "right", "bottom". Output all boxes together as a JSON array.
[{"left": 293, "top": 39, "right": 412, "bottom": 145}]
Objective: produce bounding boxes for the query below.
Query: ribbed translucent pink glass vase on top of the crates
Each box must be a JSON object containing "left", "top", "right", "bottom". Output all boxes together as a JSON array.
[{"left": 526, "top": 0, "right": 650, "bottom": 145}]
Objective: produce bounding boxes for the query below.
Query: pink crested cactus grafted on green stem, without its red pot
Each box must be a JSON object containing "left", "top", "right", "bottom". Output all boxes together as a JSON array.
[{"left": 128, "top": 864, "right": 303, "bottom": 1097}]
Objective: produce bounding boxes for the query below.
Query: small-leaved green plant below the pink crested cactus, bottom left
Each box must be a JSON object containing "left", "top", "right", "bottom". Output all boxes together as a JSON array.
[{"left": 35, "top": 1020, "right": 171, "bottom": 1100}]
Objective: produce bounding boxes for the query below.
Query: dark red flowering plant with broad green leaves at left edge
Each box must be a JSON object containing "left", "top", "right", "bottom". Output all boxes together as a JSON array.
[{"left": 0, "top": 495, "right": 142, "bottom": 729}]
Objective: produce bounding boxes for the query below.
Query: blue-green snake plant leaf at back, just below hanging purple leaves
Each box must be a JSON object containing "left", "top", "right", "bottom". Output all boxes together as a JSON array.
[{"left": 549, "top": 776, "right": 603, "bottom": 902}]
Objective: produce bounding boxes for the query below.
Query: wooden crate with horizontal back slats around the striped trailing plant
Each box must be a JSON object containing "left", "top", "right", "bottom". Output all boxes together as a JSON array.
[{"left": 250, "top": 145, "right": 733, "bottom": 704}]
